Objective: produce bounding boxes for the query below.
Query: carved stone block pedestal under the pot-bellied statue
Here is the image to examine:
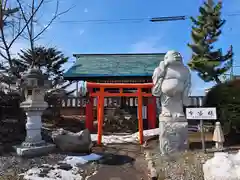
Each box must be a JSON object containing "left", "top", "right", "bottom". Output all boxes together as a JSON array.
[{"left": 159, "top": 115, "right": 188, "bottom": 155}]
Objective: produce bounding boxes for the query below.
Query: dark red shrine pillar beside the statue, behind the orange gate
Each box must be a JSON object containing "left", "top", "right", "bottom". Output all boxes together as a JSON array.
[{"left": 147, "top": 97, "right": 157, "bottom": 129}]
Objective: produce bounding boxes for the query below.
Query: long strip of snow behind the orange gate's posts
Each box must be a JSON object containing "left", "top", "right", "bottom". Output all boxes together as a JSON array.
[{"left": 91, "top": 128, "right": 159, "bottom": 145}]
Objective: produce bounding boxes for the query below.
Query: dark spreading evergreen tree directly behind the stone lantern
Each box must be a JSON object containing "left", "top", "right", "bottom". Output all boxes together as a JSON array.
[{"left": 13, "top": 46, "right": 75, "bottom": 117}]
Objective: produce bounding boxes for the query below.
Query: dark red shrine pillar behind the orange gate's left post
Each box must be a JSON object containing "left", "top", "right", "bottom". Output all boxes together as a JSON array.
[{"left": 85, "top": 88, "right": 94, "bottom": 132}]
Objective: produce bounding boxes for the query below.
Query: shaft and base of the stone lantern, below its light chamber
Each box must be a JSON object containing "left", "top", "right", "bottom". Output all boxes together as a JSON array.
[{"left": 14, "top": 101, "right": 55, "bottom": 156}]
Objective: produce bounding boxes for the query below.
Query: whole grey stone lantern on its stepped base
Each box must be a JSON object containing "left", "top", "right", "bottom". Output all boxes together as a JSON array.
[{"left": 16, "top": 68, "right": 55, "bottom": 156}]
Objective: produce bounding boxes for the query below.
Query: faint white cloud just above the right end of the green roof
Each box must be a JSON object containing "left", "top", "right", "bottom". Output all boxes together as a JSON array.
[{"left": 131, "top": 37, "right": 169, "bottom": 53}]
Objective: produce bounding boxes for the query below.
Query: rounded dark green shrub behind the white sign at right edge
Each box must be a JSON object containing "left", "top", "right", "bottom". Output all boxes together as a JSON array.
[{"left": 204, "top": 80, "right": 240, "bottom": 133}]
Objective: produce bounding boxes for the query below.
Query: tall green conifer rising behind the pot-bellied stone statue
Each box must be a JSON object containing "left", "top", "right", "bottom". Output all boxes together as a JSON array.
[{"left": 188, "top": 2, "right": 233, "bottom": 84}]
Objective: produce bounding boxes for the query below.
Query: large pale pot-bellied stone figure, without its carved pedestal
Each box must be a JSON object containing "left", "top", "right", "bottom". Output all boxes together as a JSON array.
[{"left": 152, "top": 51, "right": 191, "bottom": 117}]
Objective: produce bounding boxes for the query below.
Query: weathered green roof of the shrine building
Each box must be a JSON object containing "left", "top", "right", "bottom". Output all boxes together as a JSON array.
[{"left": 64, "top": 53, "right": 165, "bottom": 79}]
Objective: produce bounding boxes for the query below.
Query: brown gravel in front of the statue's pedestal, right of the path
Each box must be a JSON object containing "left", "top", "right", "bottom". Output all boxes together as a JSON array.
[{"left": 143, "top": 140, "right": 213, "bottom": 180}]
